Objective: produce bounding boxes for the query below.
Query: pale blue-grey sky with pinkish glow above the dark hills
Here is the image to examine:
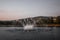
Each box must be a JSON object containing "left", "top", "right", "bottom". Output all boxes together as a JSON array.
[{"left": 0, "top": 0, "right": 60, "bottom": 20}]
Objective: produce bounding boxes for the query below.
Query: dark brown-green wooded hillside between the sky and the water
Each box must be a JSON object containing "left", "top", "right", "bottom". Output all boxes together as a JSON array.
[{"left": 0, "top": 16, "right": 60, "bottom": 27}]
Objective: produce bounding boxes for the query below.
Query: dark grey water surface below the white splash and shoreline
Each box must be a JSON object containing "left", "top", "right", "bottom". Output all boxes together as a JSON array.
[{"left": 0, "top": 27, "right": 59, "bottom": 40}]
